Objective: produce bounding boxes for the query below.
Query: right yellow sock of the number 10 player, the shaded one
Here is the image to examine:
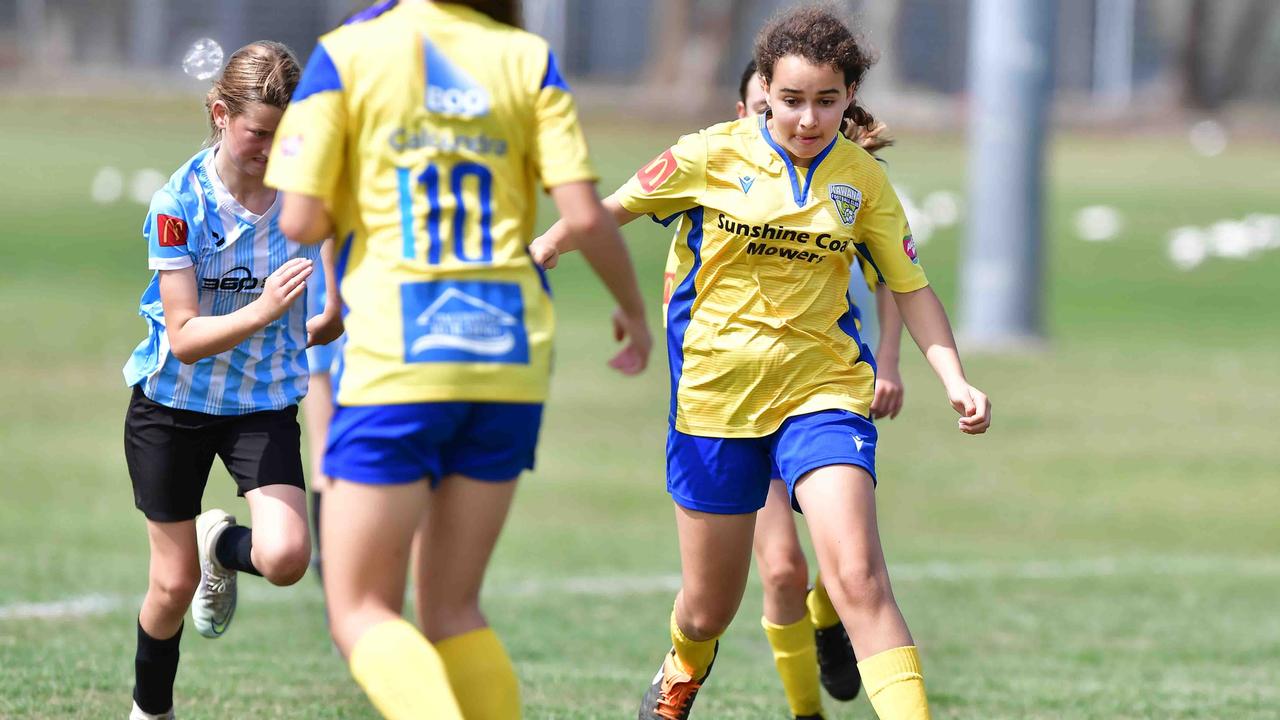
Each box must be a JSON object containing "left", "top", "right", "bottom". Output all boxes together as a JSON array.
[{"left": 435, "top": 628, "right": 520, "bottom": 720}]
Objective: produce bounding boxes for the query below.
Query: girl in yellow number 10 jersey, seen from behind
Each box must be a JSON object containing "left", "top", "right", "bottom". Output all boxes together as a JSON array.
[{"left": 266, "top": 0, "right": 650, "bottom": 720}]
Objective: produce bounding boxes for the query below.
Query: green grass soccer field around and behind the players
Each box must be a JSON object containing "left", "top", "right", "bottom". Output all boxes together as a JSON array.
[{"left": 0, "top": 97, "right": 1280, "bottom": 720}]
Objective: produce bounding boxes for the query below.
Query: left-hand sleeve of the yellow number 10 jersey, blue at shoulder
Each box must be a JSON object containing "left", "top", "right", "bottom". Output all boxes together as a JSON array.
[{"left": 266, "top": 42, "right": 347, "bottom": 202}]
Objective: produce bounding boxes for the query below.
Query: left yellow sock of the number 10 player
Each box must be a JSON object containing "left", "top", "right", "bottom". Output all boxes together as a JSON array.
[{"left": 348, "top": 620, "right": 462, "bottom": 720}]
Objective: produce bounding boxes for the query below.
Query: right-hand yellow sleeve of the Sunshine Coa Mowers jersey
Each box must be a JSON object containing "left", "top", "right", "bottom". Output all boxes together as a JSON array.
[{"left": 854, "top": 177, "right": 929, "bottom": 292}]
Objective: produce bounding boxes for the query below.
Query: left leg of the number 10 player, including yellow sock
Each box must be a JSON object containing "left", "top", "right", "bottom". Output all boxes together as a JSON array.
[{"left": 320, "top": 479, "right": 462, "bottom": 720}]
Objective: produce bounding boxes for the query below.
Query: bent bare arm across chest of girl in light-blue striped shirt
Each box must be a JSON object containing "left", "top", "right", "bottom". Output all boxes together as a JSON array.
[{"left": 160, "top": 258, "right": 312, "bottom": 364}]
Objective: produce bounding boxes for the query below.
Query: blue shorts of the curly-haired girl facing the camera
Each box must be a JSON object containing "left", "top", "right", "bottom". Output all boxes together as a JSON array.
[{"left": 667, "top": 410, "right": 877, "bottom": 515}]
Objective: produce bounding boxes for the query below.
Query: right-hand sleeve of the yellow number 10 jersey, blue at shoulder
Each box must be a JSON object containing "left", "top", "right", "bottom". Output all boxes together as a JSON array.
[{"left": 532, "top": 50, "right": 598, "bottom": 187}]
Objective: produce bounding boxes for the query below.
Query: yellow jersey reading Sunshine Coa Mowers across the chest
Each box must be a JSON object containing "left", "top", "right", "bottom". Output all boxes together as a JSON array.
[{"left": 624, "top": 115, "right": 928, "bottom": 437}]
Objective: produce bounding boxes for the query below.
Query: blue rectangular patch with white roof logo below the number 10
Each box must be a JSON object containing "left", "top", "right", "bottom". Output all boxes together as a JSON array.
[{"left": 401, "top": 281, "right": 529, "bottom": 365}]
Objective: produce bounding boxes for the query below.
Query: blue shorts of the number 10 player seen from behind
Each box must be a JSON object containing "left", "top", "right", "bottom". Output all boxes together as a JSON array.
[{"left": 324, "top": 402, "right": 543, "bottom": 487}]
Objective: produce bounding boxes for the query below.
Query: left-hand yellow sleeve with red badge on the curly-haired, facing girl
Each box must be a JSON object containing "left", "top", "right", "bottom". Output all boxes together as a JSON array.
[{"left": 613, "top": 133, "right": 707, "bottom": 224}]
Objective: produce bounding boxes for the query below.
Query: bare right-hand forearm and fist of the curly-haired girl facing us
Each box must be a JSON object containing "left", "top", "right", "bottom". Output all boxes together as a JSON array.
[{"left": 893, "top": 286, "right": 991, "bottom": 436}]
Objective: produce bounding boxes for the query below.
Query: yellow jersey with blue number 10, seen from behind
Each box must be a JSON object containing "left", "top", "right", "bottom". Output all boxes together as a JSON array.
[{"left": 266, "top": 3, "right": 595, "bottom": 405}]
